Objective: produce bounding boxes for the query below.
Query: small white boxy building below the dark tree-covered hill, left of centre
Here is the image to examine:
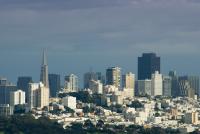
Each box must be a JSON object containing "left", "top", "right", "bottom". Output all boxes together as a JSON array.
[{"left": 62, "top": 96, "right": 76, "bottom": 110}]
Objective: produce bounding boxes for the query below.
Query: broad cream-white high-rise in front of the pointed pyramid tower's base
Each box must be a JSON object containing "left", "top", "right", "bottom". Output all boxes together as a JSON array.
[{"left": 28, "top": 82, "right": 49, "bottom": 109}]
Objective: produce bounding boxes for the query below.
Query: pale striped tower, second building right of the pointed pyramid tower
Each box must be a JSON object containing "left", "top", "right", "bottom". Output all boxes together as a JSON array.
[{"left": 65, "top": 74, "right": 78, "bottom": 92}]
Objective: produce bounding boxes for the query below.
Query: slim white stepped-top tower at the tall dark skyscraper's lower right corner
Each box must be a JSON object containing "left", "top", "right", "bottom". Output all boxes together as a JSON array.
[{"left": 152, "top": 71, "right": 163, "bottom": 96}]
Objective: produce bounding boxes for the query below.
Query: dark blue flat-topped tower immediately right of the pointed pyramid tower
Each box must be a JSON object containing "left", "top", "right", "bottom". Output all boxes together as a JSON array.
[{"left": 49, "top": 74, "right": 61, "bottom": 97}]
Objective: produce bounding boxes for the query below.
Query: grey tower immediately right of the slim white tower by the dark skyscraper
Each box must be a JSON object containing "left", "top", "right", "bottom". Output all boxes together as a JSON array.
[{"left": 163, "top": 76, "right": 172, "bottom": 96}]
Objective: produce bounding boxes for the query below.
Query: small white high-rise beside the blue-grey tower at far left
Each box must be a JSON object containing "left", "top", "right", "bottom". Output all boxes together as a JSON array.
[{"left": 10, "top": 90, "right": 25, "bottom": 106}]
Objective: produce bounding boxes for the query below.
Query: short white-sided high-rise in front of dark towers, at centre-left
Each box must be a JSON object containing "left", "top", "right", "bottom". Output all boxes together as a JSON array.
[{"left": 89, "top": 80, "right": 103, "bottom": 94}]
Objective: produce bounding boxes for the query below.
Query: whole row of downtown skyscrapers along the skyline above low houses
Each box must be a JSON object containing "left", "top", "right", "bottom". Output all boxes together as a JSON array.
[{"left": 0, "top": 52, "right": 200, "bottom": 108}]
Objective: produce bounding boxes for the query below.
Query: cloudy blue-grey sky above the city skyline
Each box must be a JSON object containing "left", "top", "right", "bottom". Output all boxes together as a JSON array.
[{"left": 0, "top": 0, "right": 200, "bottom": 86}]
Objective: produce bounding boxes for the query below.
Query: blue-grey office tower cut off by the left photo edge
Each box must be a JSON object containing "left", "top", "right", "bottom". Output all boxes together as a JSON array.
[{"left": 0, "top": 78, "right": 17, "bottom": 104}]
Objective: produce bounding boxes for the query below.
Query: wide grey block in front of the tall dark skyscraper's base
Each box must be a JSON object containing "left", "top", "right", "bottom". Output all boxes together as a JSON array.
[{"left": 137, "top": 79, "right": 152, "bottom": 95}]
